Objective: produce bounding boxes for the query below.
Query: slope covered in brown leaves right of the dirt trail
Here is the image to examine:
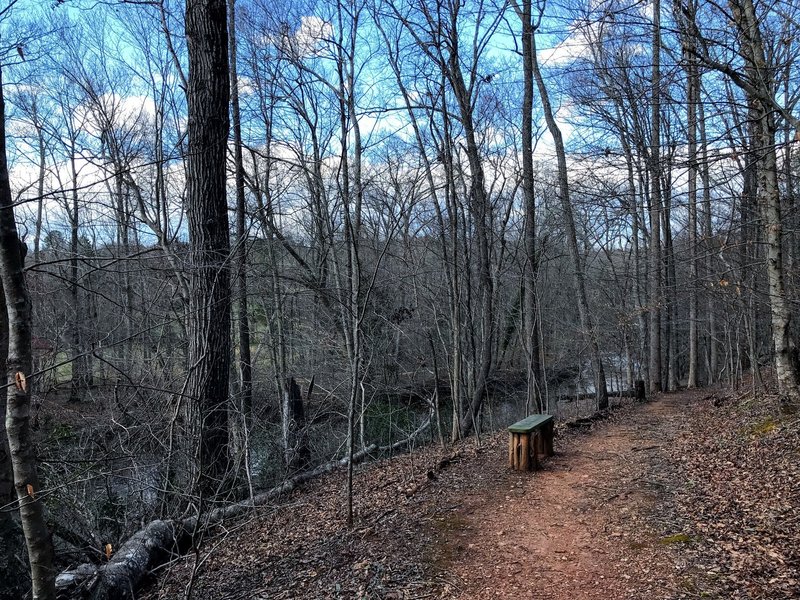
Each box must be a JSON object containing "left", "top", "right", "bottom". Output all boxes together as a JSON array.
[{"left": 672, "top": 393, "right": 800, "bottom": 599}]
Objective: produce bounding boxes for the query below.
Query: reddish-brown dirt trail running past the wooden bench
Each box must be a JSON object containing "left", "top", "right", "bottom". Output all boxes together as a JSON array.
[{"left": 442, "top": 393, "right": 696, "bottom": 600}]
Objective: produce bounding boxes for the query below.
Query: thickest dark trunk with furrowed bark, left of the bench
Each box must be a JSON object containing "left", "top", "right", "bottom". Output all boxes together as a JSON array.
[{"left": 186, "top": 0, "right": 231, "bottom": 497}]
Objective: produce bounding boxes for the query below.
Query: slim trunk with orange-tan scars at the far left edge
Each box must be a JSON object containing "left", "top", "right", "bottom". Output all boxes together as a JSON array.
[{"left": 0, "top": 64, "right": 56, "bottom": 600}]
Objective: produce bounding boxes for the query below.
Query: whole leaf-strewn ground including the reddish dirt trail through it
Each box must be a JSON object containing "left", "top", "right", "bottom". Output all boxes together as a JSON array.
[{"left": 145, "top": 390, "right": 800, "bottom": 600}]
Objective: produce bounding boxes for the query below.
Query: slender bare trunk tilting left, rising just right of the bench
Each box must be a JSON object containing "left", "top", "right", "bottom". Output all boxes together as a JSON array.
[{"left": 531, "top": 25, "right": 608, "bottom": 410}]
